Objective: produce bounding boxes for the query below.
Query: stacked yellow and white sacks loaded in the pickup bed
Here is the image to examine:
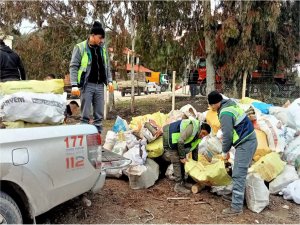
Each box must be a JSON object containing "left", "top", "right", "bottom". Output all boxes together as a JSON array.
[{"left": 0, "top": 79, "right": 67, "bottom": 128}]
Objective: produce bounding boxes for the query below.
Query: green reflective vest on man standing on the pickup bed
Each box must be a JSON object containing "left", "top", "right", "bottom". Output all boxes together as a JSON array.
[{"left": 77, "top": 40, "right": 107, "bottom": 83}]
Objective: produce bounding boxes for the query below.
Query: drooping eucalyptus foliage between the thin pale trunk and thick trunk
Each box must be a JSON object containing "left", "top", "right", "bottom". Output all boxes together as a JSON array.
[{"left": 137, "top": 1, "right": 203, "bottom": 79}]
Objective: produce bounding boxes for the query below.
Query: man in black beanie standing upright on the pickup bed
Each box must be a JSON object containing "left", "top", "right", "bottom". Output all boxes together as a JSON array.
[{"left": 70, "top": 21, "right": 114, "bottom": 133}]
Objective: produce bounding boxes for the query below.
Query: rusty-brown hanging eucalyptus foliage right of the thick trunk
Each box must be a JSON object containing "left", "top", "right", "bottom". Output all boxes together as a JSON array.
[{"left": 214, "top": 1, "right": 299, "bottom": 96}]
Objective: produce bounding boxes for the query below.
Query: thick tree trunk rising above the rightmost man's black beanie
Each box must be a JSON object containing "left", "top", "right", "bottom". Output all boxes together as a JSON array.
[{"left": 203, "top": 0, "right": 215, "bottom": 95}]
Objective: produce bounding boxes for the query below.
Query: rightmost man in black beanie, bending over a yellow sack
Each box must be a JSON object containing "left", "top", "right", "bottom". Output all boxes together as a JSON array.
[{"left": 208, "top": 91, "right": 257, "bottom": 215}]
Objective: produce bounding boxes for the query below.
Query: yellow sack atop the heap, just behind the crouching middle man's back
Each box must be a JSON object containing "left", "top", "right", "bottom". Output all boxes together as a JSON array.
[{"left": 129, "top": 112, "right": 168, "bottom": 132}]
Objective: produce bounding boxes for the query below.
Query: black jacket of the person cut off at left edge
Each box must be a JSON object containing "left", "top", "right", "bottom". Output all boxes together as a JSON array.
[{"left": 0, "top": 44, "right": 26, "bottom": 82}]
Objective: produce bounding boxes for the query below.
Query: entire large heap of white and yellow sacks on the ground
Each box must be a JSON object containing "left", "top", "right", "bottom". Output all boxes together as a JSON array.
[{"left": 104, "top": 99, "right": 300, "bottom": 213}]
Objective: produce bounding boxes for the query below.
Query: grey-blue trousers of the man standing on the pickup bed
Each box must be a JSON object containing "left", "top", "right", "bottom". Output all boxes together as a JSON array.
[{"left": 80, "top": 83, "right": 104, "bottom": 133}]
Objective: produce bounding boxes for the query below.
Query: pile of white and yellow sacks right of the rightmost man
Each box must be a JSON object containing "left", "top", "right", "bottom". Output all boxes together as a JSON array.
[{"left": 207, "top": 99, "right": 300, "bottom": 213}]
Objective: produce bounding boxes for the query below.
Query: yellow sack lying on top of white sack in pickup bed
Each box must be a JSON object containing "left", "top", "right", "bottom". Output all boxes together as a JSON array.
[{"left": 0, "top": 79, "right": 64, "bottom": 95}]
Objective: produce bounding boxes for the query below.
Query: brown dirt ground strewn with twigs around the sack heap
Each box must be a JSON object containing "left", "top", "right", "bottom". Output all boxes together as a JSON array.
[{"left": 37, "top": 98, "right": 300, "bottom": 224}]
